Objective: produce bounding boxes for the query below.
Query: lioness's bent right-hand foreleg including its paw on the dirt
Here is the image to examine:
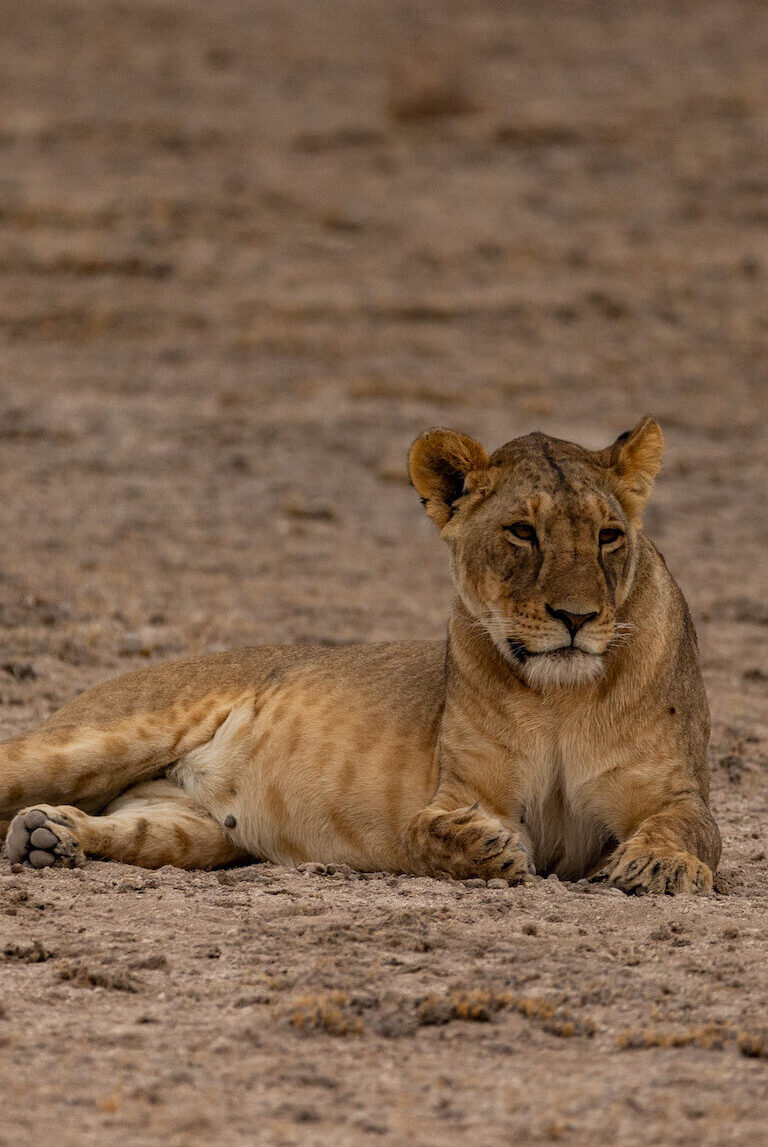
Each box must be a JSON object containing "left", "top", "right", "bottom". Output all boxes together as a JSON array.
[{"left": 593, "top": 796, "right": 720, "bottom": 895}]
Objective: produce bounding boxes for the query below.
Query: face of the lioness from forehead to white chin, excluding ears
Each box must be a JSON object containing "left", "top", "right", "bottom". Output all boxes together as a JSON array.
[{"left": 446, "top": 454, "right": 636, "bottom": 685}]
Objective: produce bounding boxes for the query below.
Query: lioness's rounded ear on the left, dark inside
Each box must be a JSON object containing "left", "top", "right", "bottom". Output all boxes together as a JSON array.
[{"left": 408, "top": 428, "right": 488, "bottom": 529}]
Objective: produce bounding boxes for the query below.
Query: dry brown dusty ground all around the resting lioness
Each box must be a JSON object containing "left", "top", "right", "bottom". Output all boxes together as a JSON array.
[{"left": 0, "top": 0, "right": 768, "bottom": 1147}]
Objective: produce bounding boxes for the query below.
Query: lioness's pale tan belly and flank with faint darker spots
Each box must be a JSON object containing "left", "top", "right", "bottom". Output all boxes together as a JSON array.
[{"left": 173, "top": 673, "right": 438, "bottom": 871}]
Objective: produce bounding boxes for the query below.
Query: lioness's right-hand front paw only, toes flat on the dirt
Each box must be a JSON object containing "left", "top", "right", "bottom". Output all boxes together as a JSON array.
[{"left": 593, "top": 841, "right": 713, "bottom": 896}]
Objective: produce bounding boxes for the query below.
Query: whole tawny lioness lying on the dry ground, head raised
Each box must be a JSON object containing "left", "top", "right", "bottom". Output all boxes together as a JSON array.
[{"left": 0, "top": 418, "right": 720, "bottom": 892}]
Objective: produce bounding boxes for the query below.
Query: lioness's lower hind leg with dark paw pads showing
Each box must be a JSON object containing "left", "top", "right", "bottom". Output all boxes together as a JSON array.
[{"left": 6, "top": 780, "right": 245, "bottom": 868}]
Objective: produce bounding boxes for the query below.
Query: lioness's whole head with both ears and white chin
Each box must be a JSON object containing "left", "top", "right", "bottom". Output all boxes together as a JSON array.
[{"left": 409, "top": 418, "right": 664, "bottom": 688}]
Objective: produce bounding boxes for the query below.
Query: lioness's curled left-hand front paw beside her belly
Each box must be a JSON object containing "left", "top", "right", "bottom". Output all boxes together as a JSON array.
[{"left": 406, "top": 795, "right": 533, "bottom": 882}]
